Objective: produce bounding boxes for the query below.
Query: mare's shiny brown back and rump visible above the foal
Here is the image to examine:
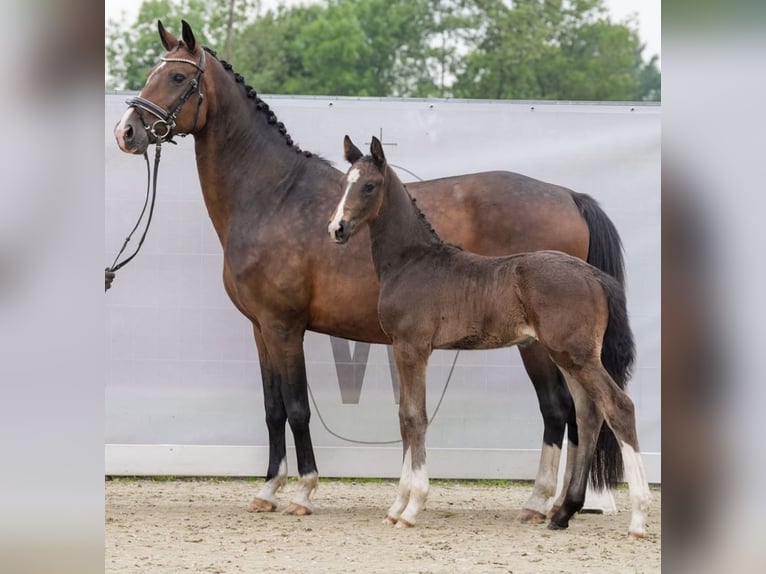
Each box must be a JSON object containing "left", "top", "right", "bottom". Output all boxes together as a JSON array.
[{"left": 407, "top": 171, "right": 589, "bottom": 259}]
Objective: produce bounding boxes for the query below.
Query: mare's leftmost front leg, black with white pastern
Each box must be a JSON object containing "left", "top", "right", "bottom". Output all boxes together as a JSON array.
[{"left": 248, "top": 326, "right": 287, "bottom": 512}]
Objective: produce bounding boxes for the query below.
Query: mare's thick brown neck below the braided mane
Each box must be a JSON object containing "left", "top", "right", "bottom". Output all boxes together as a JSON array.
[{"left": 195, "top": 70, "right": 303, "bottom": 242}]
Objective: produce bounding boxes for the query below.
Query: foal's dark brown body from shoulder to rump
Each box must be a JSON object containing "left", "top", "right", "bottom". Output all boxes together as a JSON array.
[{"left": 378, "top": 244, "right": 608, "bottom": 349}]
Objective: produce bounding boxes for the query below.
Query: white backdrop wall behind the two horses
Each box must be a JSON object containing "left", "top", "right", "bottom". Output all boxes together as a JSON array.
[{"left": 104, "top": 94, "right": 661, "bottom": 482}]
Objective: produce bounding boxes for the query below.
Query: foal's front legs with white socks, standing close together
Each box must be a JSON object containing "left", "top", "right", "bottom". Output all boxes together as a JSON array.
[{"left": 386, "top": 341, "right": 430, "bottom": 528}]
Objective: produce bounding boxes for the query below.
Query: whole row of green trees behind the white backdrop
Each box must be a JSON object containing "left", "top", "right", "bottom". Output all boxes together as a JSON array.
[{"left": 106, "top": 0, "right": 661, "bottom": 100}]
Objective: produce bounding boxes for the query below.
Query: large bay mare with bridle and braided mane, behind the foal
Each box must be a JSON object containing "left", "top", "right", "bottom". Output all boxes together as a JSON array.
[{"left": 114, "top": 22, "right": 625, "bottom": 523}]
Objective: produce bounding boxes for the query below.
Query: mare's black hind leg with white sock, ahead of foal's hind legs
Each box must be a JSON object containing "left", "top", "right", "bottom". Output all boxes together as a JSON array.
[{"left": 518, "top": 343, "right": 577, "bottom": 524}]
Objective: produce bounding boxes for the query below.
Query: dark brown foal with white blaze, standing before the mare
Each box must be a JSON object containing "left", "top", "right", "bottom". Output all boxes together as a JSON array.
[{"left": 327, "top": 136, "right": 651, "bottom": 537}]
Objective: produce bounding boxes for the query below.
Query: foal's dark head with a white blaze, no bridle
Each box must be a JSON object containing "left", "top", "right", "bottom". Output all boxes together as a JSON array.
[{"left": 327, "top": 136, "right": 388, "bottom": 243}]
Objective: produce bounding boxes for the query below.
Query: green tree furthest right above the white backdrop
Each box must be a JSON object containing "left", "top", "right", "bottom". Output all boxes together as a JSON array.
[{"left": 453, "top": 0, "right": 660, "bottom": 100}]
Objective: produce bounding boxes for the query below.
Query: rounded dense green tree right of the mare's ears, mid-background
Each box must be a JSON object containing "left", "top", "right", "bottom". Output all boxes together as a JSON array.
[{"left": 235, "top": 0, "right": 448, "bottom": 96}]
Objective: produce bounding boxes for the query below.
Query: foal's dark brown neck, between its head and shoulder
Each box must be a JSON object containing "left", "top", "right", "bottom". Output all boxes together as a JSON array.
[{"left": 369, "top": 172, "right": 439, "bottom": 274}]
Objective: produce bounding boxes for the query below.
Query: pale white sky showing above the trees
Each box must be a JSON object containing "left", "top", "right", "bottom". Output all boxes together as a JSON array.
[{"left": 104, "top": 0, "right": 662, "bottom": 63}]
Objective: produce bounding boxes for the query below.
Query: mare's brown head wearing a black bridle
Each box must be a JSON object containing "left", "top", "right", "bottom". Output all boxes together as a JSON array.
[{"left": 114, "top": 21, "right": 207, "bottom": 154}]
